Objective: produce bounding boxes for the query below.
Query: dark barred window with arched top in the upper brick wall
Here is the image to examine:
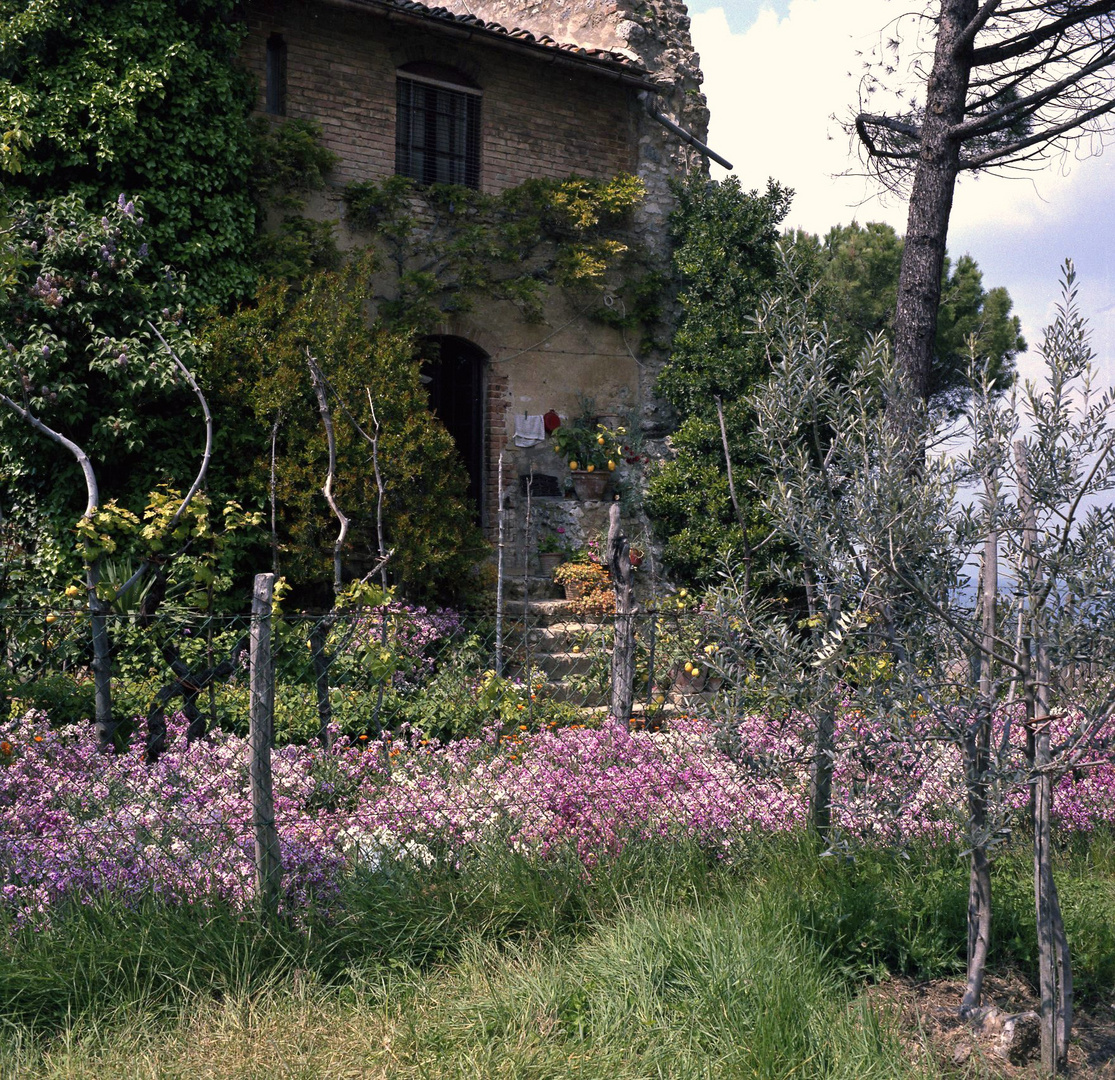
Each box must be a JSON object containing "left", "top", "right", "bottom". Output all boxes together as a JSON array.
[{"left": 395, "top": 61, "right": 481, "bottom": 188}]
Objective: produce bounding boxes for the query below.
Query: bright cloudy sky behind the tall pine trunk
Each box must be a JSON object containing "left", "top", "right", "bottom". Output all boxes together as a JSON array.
[{"left": 688, "top": 0, "right": 1115, "bottom": 383}]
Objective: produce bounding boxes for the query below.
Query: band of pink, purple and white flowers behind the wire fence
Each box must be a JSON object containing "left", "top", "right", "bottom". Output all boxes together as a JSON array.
[{"left": 0, "top": 710, "right": 1115, "bottom": 924}]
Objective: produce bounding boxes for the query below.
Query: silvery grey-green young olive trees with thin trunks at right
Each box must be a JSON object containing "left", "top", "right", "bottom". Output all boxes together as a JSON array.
[{"left": 718, "top": 263, "right": 1115, "bottom": 1072}]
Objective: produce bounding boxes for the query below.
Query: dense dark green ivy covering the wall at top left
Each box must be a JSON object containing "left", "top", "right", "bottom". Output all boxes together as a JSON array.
[{"left": 0, "top": 0, "right": 259, "bottom": 307}]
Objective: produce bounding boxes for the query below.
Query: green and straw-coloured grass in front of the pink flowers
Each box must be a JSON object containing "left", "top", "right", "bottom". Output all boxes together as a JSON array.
[{"left": 0, "top": 836, "right": 1115, "bottom": 1080}]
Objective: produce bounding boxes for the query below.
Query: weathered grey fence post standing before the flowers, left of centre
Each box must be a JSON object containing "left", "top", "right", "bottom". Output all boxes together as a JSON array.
[{"left": 249, "top": 574, "right": 282, "bottom": 915}]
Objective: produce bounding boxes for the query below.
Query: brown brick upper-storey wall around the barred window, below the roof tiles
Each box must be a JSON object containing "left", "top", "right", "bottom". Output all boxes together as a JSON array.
[{"left": 242, "top": 0, "right": 638, "bottom": 192}]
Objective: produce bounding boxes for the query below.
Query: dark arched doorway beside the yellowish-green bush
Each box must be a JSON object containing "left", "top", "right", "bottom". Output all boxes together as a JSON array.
[{"left": 421, "top": 334, "right": 488, "bottom": 524}]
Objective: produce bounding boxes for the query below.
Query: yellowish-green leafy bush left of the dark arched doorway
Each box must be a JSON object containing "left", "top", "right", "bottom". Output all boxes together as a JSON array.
[{"left": 201, "top": 254, "right": 486, "bottom": 596}]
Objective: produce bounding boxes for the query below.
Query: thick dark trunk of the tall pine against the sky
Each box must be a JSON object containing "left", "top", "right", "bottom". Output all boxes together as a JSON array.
[{"left": 889, "top": 0, "right": 978, "bottom": 416}]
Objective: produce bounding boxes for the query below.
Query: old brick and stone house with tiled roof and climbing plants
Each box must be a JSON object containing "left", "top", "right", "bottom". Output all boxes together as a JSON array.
[{"left": 242, "top": 0, "right": 708, "bottom": 579}]
